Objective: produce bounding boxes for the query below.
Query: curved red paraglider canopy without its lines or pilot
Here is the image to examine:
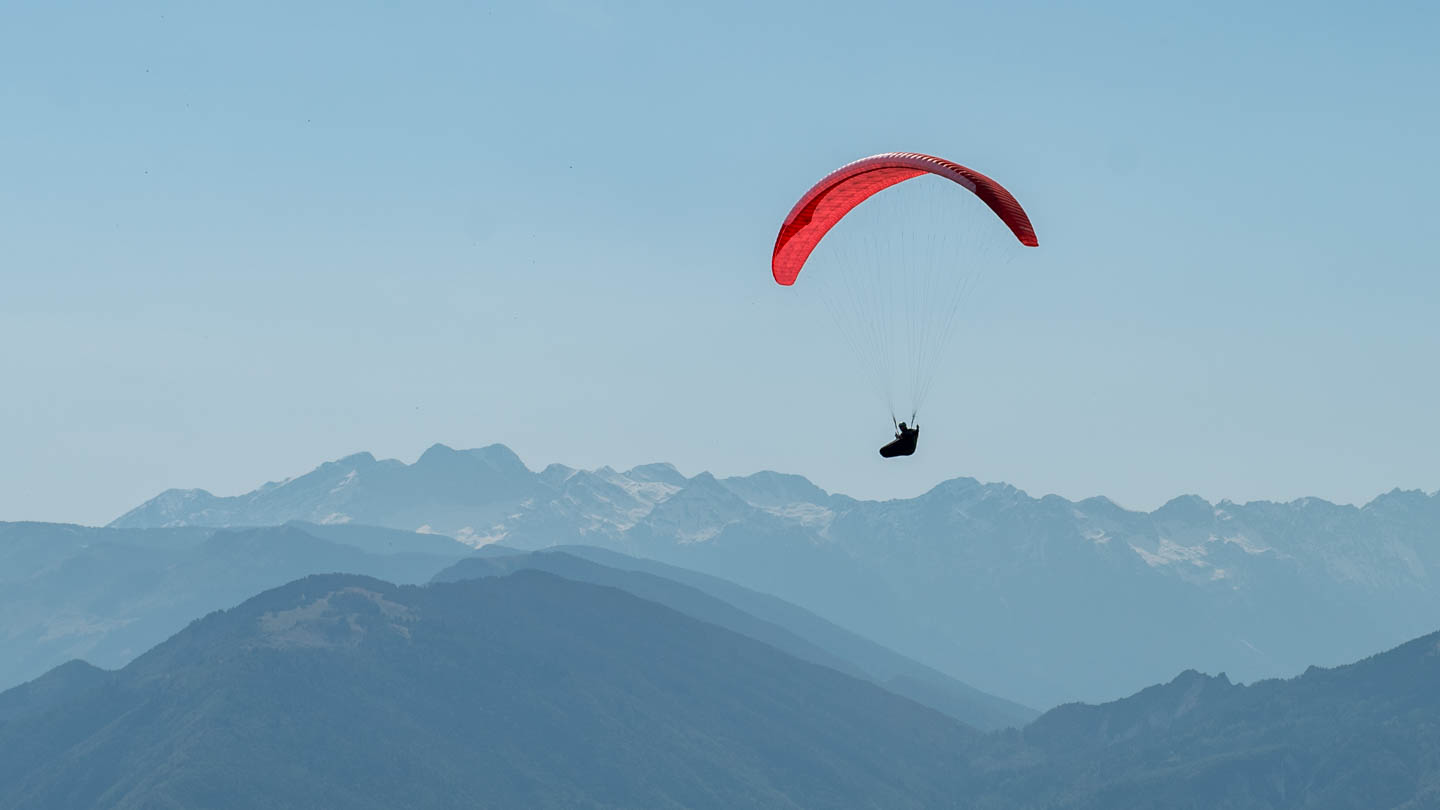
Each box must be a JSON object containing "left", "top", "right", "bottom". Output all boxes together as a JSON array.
[{"left": 770, "top": 151, "right": 1040, "bottom": 287}]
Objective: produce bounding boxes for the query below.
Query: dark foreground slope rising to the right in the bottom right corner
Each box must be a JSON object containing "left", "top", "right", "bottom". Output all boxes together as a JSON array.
[{"left": 976, "top": 634, "right": 1440, "bottom": 810}]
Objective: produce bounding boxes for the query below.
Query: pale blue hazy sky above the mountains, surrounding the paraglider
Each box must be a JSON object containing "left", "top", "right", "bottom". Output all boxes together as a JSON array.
[{"left": 0, "top": 1, "right": 1440, "bottom": 523}]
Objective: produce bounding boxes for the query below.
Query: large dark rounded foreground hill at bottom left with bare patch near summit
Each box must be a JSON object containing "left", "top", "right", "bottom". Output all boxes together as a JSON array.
[{"left": 0, "top": 571, "right": 976, "bottom": 810}]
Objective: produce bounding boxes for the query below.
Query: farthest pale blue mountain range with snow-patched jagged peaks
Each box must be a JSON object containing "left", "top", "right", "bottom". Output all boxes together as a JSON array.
[{"left": 114, "top": 445, "right": 1440, "bottom": 706}]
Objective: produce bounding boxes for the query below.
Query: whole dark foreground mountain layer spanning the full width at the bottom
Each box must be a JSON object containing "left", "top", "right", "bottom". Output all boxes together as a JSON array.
[{"left": 0, "top": 567, "right": 1440, "bottom": 810}]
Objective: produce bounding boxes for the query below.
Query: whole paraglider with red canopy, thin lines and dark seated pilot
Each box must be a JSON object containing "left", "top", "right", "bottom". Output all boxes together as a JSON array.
[{"left": 770, "top": 153, "right": 1040, "bottom": 458}]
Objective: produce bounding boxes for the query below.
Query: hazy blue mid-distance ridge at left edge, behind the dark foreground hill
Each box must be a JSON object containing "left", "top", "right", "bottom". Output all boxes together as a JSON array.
[{"left": 0, "top": 523, "right": 471, "bottom": 689}]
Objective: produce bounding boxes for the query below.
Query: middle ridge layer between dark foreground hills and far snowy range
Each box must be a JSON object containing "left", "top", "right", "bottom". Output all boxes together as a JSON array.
[{"left": 0, "top": 522, "right": 1037, "bottom": 729}]
